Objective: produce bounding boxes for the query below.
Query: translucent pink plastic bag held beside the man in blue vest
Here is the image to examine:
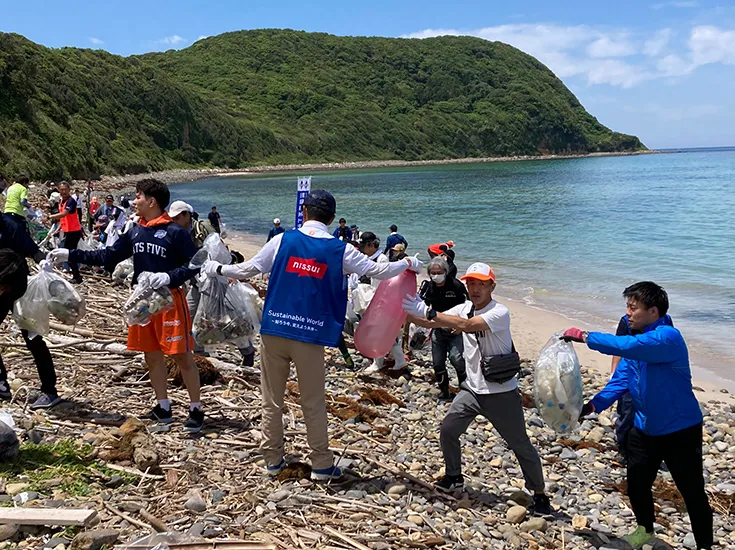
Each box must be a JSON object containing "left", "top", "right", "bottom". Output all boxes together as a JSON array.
[{"left": 355, "top": 271, "right": 416, "bottom": 359}]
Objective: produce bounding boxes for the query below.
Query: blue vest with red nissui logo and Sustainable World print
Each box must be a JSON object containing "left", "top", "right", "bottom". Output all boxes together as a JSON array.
[{"left": 260, "top": 230, "right": 347, "bottom": 347}]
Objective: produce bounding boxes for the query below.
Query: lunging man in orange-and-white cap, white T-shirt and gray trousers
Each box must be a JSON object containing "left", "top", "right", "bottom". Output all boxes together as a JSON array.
[{"left": 403, "top": 263, "right": 553, "bottom": 515}]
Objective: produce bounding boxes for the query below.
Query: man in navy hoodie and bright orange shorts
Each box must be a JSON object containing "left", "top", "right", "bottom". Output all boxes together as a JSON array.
[{"left": 49, "top": 179, "right": 204, "bottom": 432}]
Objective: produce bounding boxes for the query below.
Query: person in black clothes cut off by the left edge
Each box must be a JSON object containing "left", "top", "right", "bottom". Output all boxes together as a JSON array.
[{"left": 0, "top": 214, "right": 61, "bottom": 409}]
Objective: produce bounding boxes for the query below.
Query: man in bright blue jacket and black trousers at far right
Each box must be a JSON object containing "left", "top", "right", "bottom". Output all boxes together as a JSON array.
[{"left": 562, "top": 281, "right": 713, "bottom": 549}]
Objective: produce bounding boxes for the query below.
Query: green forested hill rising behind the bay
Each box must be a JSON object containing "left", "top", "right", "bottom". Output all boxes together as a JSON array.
[{"left": 0, "top": 30, "right": 643, "bottom": 178}]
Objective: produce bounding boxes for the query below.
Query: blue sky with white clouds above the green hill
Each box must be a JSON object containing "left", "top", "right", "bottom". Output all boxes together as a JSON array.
[{"left": 0, "top": 0, "right": 735, "bottom": 148}]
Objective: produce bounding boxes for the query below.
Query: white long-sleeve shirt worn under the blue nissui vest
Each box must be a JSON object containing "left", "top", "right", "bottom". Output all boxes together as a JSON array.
[{"left": 222, "top": 220, "right": 411, "bottom": 280}]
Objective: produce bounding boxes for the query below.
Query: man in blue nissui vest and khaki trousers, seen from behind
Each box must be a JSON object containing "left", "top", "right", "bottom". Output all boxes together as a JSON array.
[{"left": 202, "top": 191, "right": 422, "bottom": 480}]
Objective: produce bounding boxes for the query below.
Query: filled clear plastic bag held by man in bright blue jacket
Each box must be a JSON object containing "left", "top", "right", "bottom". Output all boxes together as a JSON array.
[{"left": 533, "top": 332, "right": 584, "bottom": 433}]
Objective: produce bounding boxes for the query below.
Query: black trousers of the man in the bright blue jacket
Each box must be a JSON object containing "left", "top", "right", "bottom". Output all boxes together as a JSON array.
[{"left": 627, "top": 424, "right": 713, "bottom": 548}]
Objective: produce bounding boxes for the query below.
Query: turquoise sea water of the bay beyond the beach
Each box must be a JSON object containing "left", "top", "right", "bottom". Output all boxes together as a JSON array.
[{"left": 172, "top": 149, "right": 735, "bottom": 377}]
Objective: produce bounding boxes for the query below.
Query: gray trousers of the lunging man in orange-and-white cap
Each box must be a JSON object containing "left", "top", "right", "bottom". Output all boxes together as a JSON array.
[{"left": 441, "top": 387, "right": 545, "bottom": 492}]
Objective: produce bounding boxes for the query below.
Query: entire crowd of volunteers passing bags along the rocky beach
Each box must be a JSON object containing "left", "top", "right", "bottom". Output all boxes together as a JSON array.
[{"left": 0, "top": 176, "right": 713, "bottom": 549}]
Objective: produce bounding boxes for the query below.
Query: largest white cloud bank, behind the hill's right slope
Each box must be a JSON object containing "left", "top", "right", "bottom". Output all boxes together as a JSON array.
[{"left": 406, "top": 23, "right": 735, "bottom": 88}]
